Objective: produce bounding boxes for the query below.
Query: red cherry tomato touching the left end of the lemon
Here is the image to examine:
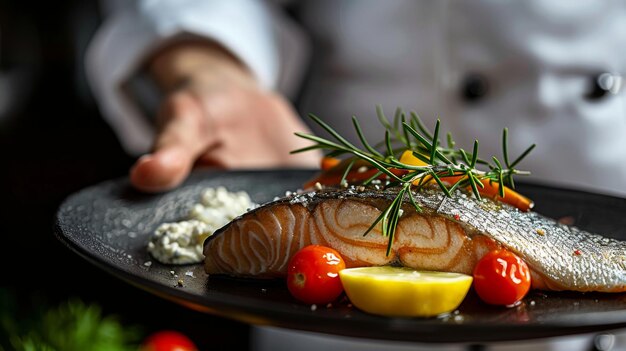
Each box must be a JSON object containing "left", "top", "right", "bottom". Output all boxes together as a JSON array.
[{"left": 287, "top": 245, "right": 346, "bottom": 304}]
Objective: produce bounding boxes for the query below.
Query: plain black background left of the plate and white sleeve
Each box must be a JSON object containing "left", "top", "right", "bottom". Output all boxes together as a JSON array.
[{"left": 0, "top": 0, "right": 249, "bottom": 350}]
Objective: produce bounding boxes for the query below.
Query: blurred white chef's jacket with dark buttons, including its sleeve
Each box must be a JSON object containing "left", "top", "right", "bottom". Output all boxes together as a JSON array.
[{"left": 86, "top": 0, "right": 626, "bottom": 350}]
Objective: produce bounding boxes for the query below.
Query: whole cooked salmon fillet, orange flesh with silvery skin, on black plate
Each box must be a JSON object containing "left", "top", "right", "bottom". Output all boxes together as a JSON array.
[{"left": 204, "top": 187, "right": 626, "bottom": 292}]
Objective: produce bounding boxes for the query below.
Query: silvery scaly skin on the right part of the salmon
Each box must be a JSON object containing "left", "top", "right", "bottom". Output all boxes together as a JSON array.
[{"left": 421, "top": 188, "right": 626, "bottom": 292}]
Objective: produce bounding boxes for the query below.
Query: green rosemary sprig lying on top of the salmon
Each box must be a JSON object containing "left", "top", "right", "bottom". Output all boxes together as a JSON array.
[{"left": 292, "top": 105, "right": 535, "bottom": 255}]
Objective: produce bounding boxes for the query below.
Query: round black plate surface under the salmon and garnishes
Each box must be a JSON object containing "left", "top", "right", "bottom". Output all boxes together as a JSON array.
[{"left": 56, "top": 171, "right": 626, "bottom": 342}]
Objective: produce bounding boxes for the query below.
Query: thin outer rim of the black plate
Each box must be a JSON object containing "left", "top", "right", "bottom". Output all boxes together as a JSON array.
[{"left": 54, "top": 169, "right": 626, "bottom": 343}]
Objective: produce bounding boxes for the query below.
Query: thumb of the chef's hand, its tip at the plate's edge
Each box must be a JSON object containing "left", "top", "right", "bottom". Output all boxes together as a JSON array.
[{"left": 130, "top": 93, "right": 209, "bottom": 192}]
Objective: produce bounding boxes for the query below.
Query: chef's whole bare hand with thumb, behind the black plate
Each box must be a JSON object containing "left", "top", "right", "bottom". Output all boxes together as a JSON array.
[{"left": 130, "top": 42, "right": 320, "bottom": 192}]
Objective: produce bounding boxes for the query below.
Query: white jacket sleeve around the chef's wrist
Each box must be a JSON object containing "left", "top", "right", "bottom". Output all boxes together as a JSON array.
[{"left": 85, "top": 0, "right": 279, "bottom": 154}]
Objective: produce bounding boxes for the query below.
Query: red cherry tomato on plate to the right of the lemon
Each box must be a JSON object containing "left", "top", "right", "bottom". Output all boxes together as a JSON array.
[{"left": 474, "top": 250, "right": 530, "bottom": 306}]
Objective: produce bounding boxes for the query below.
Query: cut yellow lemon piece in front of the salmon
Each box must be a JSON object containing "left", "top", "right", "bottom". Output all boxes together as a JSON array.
[{"left": 339, "top": 266, "right": 472, "bottom": 317}]
